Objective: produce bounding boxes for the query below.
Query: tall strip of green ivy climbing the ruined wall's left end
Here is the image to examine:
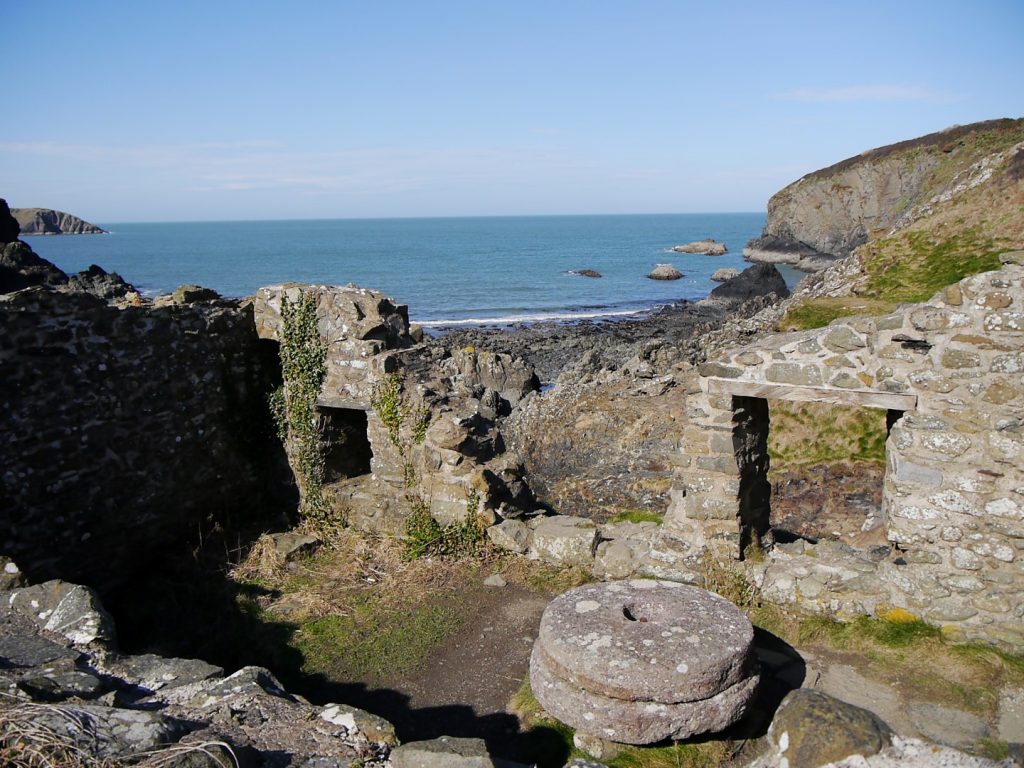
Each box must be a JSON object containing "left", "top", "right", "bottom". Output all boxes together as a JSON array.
[{"left": 269, "top": 293, "right": 330, "bottom": 523}]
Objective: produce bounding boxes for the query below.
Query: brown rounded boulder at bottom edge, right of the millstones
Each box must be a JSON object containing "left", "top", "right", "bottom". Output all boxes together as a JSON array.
[{"left": 768, "top": 688, "right": 893, "bottom": 768}]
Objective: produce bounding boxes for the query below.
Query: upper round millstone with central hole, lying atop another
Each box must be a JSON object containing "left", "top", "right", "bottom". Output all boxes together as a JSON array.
[{"left": 537, "top": 579, "right": 757, "bottom": 705}]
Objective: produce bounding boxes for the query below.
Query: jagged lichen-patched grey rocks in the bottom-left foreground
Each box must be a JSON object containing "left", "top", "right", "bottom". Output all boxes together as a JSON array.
[{"left": 0, "top": 569, "right": 399, "bottom": 768}]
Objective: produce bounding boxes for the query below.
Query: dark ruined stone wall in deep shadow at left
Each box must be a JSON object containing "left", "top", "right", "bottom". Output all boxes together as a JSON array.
[{"left": 0, "top": 288, "right": 288, "bottom": 591}]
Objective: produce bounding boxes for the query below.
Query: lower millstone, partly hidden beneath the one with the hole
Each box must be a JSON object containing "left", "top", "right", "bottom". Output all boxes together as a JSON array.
[{"left": 529, "top": 645, "right": 759, "bottom": 744}]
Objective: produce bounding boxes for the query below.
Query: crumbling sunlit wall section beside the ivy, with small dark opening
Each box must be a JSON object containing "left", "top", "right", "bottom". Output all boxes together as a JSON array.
[{"left": 255, "top": 284, "right": 537, "bottom": 534}]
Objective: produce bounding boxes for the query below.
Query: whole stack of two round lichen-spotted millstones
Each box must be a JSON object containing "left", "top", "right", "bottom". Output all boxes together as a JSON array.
[{"left": 530, "top": 580, "right": 758, "bottom": 743}]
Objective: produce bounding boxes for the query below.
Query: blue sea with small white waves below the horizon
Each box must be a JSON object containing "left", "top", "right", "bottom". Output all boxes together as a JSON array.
[{"left": 29, "top": 213, "right": 764, "bottom": 326}]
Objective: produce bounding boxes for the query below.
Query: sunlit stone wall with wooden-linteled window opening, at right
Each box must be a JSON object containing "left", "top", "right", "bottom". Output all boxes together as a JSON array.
[{"left": 666, "top": 252, "right": 1024, "bottom": 648}]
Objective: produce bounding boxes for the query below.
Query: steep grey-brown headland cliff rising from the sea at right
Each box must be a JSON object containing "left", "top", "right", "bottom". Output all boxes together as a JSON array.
[{"left": 743, "top": 119, "right": 1024, "bottom": 271}]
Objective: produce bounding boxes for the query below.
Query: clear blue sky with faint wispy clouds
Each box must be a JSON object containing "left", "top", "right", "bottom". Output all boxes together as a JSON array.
[{"left": 0, "top": 0, "right": 1024, "bottom": 222}]
